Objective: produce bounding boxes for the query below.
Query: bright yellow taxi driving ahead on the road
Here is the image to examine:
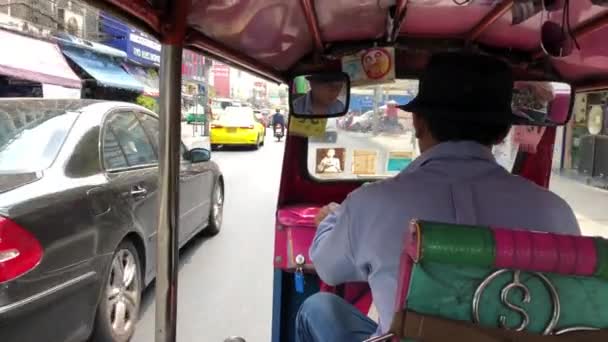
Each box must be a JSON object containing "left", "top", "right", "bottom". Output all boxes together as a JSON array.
[{"left": 210, "top": 107, "right": 266, "bottom": 149}]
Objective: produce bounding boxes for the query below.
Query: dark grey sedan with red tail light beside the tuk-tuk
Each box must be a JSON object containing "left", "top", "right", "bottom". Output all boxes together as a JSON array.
[{"left": 0, "top": 99, "right": 224, "bottom": 342}]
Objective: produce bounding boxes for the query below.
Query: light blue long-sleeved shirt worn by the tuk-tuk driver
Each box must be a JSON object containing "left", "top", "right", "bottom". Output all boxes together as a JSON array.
[{"left": 310, "top": 141, "right": 580, "bottom": 333}]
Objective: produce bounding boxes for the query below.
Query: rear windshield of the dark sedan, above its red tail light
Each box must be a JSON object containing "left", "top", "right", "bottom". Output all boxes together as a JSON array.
[{"left": 0, "top": 109, "right": 78, "bottom": 173}]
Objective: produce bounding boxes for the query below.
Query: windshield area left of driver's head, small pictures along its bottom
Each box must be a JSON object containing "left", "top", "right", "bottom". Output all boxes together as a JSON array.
[{"left": 308, "top": 80, "right": 419, "bottom": 179}]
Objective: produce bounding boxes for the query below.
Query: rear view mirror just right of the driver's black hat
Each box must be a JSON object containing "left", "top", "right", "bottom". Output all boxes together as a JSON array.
[{"left": 511, "top": 81, "right": 574, "bottom": 126}]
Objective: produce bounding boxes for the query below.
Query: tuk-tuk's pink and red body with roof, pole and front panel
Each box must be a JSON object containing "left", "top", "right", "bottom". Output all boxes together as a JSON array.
[{"left": 82, "top": 0, "right": 608, "bottom": 341}]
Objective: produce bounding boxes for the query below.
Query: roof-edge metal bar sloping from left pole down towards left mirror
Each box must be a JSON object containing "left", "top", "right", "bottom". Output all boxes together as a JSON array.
[{"left": 187, "top": 30, "right": 287, "bottom": 83}]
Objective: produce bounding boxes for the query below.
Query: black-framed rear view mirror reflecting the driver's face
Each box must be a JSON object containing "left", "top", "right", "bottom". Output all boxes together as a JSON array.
[{"left": 289, "top": 72, "right": 350, "bottom": 119}]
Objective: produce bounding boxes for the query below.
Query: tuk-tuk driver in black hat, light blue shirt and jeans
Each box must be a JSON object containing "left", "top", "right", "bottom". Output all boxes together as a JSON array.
[{"left": 296, "top": 53, "right": 580, "bottom": 342}]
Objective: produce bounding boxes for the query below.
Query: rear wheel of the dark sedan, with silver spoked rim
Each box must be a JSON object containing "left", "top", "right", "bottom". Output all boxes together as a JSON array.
[{"left": 91, "top": 241, "right": 143, "bottom": 342}]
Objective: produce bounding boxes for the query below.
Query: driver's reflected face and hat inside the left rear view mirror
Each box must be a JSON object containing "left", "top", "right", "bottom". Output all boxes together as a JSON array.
[{"left": 293, "top": 74, "right": 344, "bottom": 115}]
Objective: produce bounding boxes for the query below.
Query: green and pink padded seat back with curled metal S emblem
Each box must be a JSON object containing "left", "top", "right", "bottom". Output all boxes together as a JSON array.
[{"left": 388, "top": 221, "right": 608, "bottom": 341}]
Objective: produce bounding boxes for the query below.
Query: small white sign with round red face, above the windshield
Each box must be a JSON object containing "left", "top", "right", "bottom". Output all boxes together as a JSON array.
[{"left": 342, "top": 47, "right": 395, "bottom": 86}]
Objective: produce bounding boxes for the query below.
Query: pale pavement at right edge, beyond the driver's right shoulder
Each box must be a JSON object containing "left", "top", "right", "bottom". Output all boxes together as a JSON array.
[{"left": 549, "top": 173, "right": 608, "bottom": 238}]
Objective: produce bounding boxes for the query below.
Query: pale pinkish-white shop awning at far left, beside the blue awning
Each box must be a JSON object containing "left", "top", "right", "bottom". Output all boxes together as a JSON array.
[{"left": 0, "top": 30, "right": 82, "bottom": 88}]
